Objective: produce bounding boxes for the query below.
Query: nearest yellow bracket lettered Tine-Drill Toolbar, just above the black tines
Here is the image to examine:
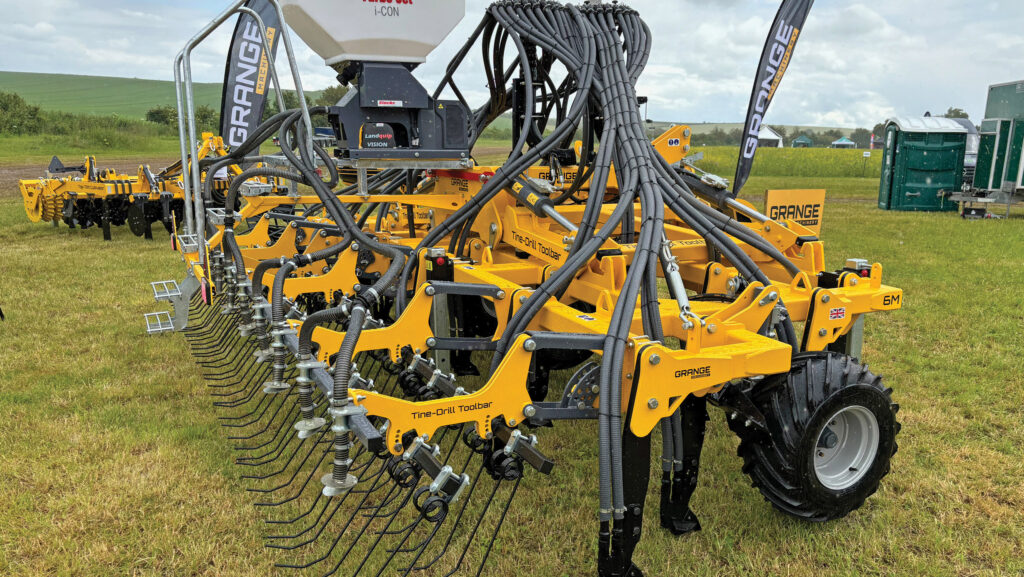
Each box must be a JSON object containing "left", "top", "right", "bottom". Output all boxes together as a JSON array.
[{"left": 348, "top": 333, "right": 532, "bottom": 455}]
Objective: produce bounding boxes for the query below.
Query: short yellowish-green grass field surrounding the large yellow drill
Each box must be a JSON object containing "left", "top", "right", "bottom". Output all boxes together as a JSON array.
[{"left": 0, "top": 151, "right": 1024, "bottom": 577}]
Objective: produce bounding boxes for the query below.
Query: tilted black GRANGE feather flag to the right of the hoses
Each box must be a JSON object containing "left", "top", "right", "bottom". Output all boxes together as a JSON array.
[{"left": 732, "top": 0, "right": 814, "bottom": 196}]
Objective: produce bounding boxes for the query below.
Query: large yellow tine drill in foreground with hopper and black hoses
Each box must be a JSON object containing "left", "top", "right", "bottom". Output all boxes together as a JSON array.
[{"left": 151, "top": 0, "right": 902, "bottom": 576}]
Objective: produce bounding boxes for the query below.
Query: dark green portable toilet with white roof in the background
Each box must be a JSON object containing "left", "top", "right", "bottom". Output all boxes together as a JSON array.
[{"left": 879, "top": 117, "right": 968, "bottom": 211}]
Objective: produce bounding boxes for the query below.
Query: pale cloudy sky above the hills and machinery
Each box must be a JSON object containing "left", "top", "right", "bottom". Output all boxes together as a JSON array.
[{"left": 0, "top": 0, "right": 1024, "bottom": 128}]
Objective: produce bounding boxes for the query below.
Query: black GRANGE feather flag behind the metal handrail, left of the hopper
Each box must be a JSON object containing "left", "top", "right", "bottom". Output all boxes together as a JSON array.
[{"left": 220, "top": 0, "right": 281, "bottom": 147}]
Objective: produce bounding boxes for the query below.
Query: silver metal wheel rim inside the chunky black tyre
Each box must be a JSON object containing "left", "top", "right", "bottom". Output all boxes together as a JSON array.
[{"left": 814, "top": 405, "right": 881, "bottom": 491}]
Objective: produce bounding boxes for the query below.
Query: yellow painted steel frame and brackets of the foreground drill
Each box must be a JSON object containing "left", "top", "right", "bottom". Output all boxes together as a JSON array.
[{"left": 180, "top": 127, "right": 902, "bottom": 454}]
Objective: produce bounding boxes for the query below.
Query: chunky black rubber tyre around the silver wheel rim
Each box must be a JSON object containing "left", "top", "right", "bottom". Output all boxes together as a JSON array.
[{"left": 729, "top": 353, "right": 900, "bottom": 522}]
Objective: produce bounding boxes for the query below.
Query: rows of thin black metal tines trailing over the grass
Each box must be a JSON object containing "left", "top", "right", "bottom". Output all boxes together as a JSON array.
[{"left": 184, "top": 254, "right": 523, "bottom": 576}]
